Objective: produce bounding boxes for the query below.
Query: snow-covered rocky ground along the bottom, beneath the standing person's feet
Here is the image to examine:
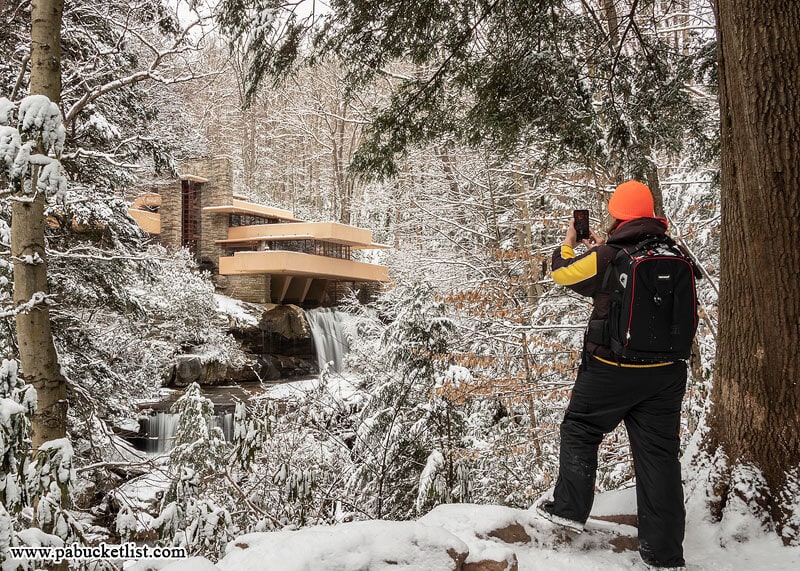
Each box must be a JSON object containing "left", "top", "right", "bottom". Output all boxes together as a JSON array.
[{"left": 126, "top": 488, "right": 800, "bottom": 571}]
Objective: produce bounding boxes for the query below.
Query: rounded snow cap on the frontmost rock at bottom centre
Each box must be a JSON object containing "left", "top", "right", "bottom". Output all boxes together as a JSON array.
[{"left": 218, "top": 520, "right": 467, "bottom": 571}]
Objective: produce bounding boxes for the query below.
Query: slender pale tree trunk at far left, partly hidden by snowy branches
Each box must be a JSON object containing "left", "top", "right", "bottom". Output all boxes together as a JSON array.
[{"left": 11, "top": 0, "right": 67, "bottom": 452}]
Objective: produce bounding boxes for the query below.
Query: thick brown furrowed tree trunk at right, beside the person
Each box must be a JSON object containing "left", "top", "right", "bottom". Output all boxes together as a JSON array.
[{"left": 708, "top": 0, "right": 800, "bottom": 538}]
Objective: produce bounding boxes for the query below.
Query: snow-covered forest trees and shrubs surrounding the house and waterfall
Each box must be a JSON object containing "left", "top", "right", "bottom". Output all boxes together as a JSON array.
[{"left": 0, "top": 0, "right": 800, "bottom": 568}]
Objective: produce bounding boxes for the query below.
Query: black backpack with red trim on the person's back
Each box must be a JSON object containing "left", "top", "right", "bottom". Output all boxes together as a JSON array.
[{"left": 589, "top": 235, "right": 700, "bottom": 363}]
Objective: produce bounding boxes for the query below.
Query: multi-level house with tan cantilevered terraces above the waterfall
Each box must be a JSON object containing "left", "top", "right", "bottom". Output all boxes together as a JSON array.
[{"left": 128, "top": 158, "right": 389, "bottom": 307}]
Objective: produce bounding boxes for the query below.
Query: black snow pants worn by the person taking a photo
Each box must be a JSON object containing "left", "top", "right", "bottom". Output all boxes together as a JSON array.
[{"left": 553, "top": 356, "right": 686, "bottom": 567}]
